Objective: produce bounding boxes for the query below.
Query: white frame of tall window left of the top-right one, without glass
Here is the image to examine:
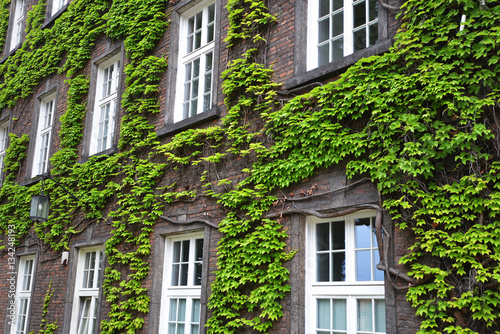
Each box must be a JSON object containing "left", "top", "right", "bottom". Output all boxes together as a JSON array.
[{"left": 174, "top": 1, "right": 217, "bottom": 123}]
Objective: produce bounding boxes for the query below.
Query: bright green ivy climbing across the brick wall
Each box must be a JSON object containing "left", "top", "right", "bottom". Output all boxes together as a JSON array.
[{"left": 0, "top": 0, "right": 500, "bottom": 333}]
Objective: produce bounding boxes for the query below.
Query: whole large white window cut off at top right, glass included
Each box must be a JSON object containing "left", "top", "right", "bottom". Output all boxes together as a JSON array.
[{"left": 307, "top": 0, "right": 379, "bottom": 70}]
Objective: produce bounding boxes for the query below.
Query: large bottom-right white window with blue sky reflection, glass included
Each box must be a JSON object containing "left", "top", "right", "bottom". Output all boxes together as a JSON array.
[{"left": 306, "top": 211, "right": 386, "bottom": 334}]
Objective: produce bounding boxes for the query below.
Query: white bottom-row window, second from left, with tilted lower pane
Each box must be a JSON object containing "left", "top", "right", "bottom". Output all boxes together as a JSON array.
[{"left": 71, "top": 246, "right": 104, "bottom": 334}]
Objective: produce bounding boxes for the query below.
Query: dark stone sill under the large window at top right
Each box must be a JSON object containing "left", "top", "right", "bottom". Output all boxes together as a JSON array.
[{"left": 285, "top": 39, "right": 392, "bottom": 90}]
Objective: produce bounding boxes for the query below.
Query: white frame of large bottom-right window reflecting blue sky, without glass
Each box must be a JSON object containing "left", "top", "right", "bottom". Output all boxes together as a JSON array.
[{"left": 305, "top": 211, "right": 385, "bottom": 334}]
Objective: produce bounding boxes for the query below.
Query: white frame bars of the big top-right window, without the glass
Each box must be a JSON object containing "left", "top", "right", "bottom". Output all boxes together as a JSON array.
[{"left": 307, "top": 0, "right": 380, "bottom": 71}]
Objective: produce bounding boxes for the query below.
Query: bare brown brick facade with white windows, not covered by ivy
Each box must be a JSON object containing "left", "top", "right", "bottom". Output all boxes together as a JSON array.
[{"left": 0, "top": 0, "right": 418, "bottom": 334}]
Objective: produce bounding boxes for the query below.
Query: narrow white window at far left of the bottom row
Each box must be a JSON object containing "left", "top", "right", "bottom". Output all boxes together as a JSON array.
[{"left": 10, "top": 255, "right": 35, "bottom": 334}]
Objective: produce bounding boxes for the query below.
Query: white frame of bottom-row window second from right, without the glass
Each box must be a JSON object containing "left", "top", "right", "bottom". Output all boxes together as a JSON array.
[{"left": 159, "top": 232, "right": 206, "bottom": 334}]
